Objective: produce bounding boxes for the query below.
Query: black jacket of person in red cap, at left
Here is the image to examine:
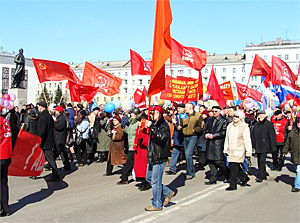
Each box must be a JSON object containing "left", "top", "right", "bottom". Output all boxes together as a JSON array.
[{"left": 54, "top": 114, "right": 67, "bottom": 147}]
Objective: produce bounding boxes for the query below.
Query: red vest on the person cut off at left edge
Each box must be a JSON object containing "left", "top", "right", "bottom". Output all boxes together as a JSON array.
[{"left": 0, "top": 116, "right": 12, "bottom": 160}]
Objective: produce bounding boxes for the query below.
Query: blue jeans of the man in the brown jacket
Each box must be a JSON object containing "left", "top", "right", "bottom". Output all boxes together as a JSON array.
[{"left": 183, "top": 136, "right": 198, "bottom": 177}]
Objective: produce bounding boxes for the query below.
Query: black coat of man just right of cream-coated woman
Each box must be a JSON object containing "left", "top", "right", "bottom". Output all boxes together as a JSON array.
[{"left": 251, "top": 118, "right": 276, "bottom": 153}]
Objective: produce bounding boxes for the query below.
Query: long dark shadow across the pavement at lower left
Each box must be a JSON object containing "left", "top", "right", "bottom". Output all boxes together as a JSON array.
[{"left": 10, "top": 181, "right": 69, "bottom": 214}]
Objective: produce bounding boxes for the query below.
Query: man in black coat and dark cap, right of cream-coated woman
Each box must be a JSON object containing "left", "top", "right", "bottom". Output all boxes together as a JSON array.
[{"left": 251, "top": 110, "right": 276, "bottom": 183}]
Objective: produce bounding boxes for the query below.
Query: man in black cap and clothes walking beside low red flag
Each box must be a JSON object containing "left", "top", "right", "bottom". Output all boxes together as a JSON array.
[{"left": 37, "top": 102, "right": 60, "bottom": 182}]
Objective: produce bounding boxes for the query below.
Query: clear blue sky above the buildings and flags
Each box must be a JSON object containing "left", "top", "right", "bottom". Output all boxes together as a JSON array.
[{"left": 0, "top": 0, "right": 300, "bottom": 63}]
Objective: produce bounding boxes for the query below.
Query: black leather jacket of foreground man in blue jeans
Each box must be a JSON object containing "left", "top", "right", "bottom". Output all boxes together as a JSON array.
[{"left": 147, "top": 118, "right": 171, "bottom": 164}]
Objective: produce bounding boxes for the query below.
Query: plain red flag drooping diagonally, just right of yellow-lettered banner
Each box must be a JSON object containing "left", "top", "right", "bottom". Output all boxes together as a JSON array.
[{"left": 207, "top": 66, "right": 226, "bottom": 107}]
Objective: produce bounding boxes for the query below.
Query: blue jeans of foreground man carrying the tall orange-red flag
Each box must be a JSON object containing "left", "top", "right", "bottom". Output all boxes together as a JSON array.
[{"left": 146, "top": 162, "right": 172, "bottom": 208}]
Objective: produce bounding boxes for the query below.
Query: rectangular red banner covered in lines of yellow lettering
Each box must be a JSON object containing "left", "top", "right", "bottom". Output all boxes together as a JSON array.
[{"left": 160, "top": 75, "right": 199, "bottom": 101}]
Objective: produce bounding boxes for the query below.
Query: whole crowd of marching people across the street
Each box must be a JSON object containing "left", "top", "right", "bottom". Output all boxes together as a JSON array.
[{"left": 0, "top": 102, "right": 300, "bottom": 216}]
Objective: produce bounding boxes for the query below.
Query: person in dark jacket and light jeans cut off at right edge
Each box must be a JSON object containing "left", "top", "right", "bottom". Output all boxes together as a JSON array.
[{"left": 282, "top": 113, "right": 300, "bottom": 192}]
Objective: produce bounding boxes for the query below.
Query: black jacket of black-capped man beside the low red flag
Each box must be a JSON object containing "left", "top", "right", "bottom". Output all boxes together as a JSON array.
[{"left": 37, "top": 110, "right": 55, "bottom": 150}]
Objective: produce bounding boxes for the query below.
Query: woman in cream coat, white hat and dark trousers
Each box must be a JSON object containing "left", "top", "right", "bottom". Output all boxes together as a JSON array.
[{"left": 223, "top": 110, "right": 252, "bottom": 191}]
